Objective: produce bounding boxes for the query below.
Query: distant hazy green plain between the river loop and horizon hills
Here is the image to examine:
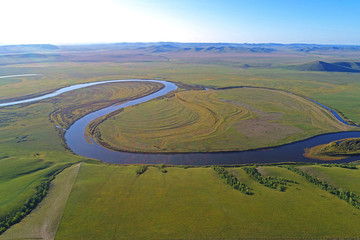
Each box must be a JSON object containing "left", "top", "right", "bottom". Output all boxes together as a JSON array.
[{"left": 0, "top": 53, "right": 360, "bottom": 123}]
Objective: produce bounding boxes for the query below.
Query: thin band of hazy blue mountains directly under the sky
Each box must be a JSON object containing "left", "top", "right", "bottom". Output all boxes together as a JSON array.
[{"left": 0, "top": 42, "right": 360, "bottom": 54}]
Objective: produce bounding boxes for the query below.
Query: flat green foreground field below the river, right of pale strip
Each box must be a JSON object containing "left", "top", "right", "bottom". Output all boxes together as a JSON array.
[{"left": 56, "top": 164, "right": 360, "bottom": 239}]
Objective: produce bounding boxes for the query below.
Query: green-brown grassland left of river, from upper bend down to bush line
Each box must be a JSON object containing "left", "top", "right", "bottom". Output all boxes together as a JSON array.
[{"left": 0, "top": 83, "right": 160, "bottom": 223}]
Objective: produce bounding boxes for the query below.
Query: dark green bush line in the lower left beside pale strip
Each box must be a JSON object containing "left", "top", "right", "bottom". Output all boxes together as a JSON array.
[{"left": 0, "top": 164, "right": 71, "bottom": 235}]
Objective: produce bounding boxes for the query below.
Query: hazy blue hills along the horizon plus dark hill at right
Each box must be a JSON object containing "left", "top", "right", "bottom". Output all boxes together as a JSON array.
[{"left": 0, "top": 42, "right": 360, "bottom": 67}]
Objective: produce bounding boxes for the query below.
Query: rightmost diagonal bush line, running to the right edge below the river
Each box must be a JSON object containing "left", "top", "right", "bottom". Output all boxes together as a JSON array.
[{"left": 283, "top": 166, "right": 360, "bottom": 209}]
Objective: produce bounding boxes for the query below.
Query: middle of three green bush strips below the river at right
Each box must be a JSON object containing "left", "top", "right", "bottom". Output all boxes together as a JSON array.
[{"left": 243, "top": 167, "right": 297, "bottom": 192}]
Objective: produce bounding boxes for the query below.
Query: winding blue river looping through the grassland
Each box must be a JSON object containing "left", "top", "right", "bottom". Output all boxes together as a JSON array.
[{"left": 0, "top": 75, "right": 360, "bottom": 165}]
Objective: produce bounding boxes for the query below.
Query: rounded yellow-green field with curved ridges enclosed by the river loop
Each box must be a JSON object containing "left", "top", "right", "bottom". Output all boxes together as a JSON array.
[{"left": 94, "top": 88, "right": 356, "bottom": 152}]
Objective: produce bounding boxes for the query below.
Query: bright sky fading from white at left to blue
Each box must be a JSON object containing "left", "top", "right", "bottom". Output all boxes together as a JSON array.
[{"left": 0, "top": 0, "right": 360, "bottom": 44}]
